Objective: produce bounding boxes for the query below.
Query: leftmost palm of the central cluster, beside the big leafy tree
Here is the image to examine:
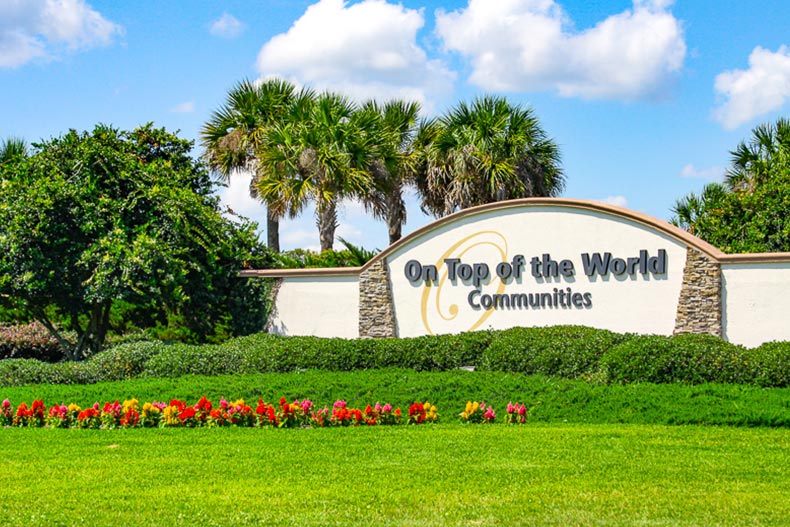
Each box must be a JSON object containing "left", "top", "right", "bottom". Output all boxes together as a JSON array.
[{"left": 201, "top": 79, "right": 296, "bottom": 251}]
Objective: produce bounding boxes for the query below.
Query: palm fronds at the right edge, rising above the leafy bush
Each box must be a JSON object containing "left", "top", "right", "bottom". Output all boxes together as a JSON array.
[{"left": 725, "top": 118, "right": 790, "bottom": 191}]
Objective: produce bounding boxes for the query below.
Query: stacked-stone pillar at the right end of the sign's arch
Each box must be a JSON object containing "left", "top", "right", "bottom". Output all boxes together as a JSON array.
[{"left": 674, "top": 248, "right": 722, "bottom": 337}]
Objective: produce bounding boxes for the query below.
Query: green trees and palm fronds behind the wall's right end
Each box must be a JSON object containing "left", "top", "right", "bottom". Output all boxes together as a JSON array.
[{"left": 670, "top": 119, "right": 790, "bottom": 253}]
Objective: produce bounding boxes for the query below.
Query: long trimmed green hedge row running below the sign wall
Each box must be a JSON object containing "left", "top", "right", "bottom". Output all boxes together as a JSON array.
[{"left": 0, "top": 326, "right": 790, "bottom": 387}]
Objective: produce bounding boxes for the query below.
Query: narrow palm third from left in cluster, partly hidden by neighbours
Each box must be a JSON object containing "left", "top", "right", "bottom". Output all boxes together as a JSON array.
[{"left": 360, "top": 100, "right": 420, "bottom": 244}]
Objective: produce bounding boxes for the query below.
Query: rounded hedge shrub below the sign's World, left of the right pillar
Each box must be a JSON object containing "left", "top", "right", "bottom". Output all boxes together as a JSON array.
[{"left": 481, "top": 326, "right": 632, "bottom": 379}]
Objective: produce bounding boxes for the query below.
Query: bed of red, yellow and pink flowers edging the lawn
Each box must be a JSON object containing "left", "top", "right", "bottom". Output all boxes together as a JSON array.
[{"left": 0, "top": 397, "right": 526, "bottom": 429}]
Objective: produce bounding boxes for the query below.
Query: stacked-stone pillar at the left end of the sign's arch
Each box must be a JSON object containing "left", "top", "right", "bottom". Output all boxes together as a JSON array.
[{"left": 359, "top": 259, "right": 395, "bottom": 338}]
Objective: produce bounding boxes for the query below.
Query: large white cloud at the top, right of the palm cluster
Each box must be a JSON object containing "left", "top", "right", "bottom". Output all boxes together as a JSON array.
[{"left": 436, "top": 0, "right": 686, "bottom": 99}]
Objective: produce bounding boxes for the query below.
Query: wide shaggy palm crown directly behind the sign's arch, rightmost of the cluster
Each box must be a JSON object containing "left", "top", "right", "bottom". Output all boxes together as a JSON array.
[{"left": 417, "top": 96, "right": 565, "bottom": 216}]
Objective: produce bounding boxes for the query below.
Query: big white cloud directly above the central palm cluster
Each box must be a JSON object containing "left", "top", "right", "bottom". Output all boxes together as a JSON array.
[{"left": 257, "top": 0, "right": 454, "bottom": 107}]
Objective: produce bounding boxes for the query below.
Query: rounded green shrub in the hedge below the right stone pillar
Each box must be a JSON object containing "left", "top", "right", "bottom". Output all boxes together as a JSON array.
[{"left": 601, "top": 334, "right": 754, "bottom": 384}]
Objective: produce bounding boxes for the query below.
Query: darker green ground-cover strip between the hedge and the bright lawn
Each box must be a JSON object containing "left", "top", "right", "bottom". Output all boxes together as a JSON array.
[{"left": 0, "top": 369, "right": 790, "bottom": 427}]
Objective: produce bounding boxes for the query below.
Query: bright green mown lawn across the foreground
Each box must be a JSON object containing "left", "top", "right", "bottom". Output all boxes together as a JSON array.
[{"left": 0, "top": 424, "right": 790, "bottom": 527}]
